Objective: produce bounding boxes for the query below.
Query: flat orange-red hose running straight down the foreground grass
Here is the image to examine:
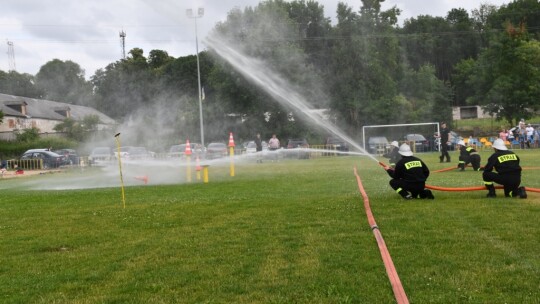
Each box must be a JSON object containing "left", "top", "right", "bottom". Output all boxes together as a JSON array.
[{"left": 354, "top": 163, "right": 409, "bottom": 304}]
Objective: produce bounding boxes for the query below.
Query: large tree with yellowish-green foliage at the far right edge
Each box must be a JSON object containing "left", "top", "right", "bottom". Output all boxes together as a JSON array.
[{"left": 468, "top": 23, "right": 540, "bottom": 124}]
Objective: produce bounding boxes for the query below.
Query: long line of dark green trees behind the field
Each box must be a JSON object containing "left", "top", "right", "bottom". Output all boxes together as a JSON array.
[{"left": 0, "top": 0, "right": 540, "bottom": 146}]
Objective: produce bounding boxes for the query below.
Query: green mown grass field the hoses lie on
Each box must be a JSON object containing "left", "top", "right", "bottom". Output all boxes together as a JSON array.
[{"left": 0, "top": 150, "right": 540, "bottom": 303}]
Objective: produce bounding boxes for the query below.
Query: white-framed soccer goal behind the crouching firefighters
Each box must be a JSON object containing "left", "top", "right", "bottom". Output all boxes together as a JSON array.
[{"left": 362, "top": 122, "right": 440, "bottom": 154}]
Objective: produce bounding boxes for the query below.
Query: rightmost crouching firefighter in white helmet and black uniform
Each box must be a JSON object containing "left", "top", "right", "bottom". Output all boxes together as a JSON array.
[{"left": 482, "top": 138, "right": 527, "bottom": 198}]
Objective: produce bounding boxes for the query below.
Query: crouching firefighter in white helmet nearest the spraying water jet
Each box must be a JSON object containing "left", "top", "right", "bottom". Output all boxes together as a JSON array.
[{"left": 384, "top": 144, "right": 435, "bottom": 199}]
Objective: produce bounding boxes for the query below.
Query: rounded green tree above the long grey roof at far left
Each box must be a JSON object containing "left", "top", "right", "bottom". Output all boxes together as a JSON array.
[{"left": 36, "top": 59, "right": 94, "bottom": 106}]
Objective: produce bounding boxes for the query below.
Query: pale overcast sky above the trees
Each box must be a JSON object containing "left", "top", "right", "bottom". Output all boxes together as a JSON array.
[{"left": 0, "top": 0, "right": 510, "bottom": 78}]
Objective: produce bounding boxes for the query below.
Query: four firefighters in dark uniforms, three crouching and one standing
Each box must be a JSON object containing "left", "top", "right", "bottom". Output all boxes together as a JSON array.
[{"left": 384, "top": 123, "right": 527, "bottom": 200}]
